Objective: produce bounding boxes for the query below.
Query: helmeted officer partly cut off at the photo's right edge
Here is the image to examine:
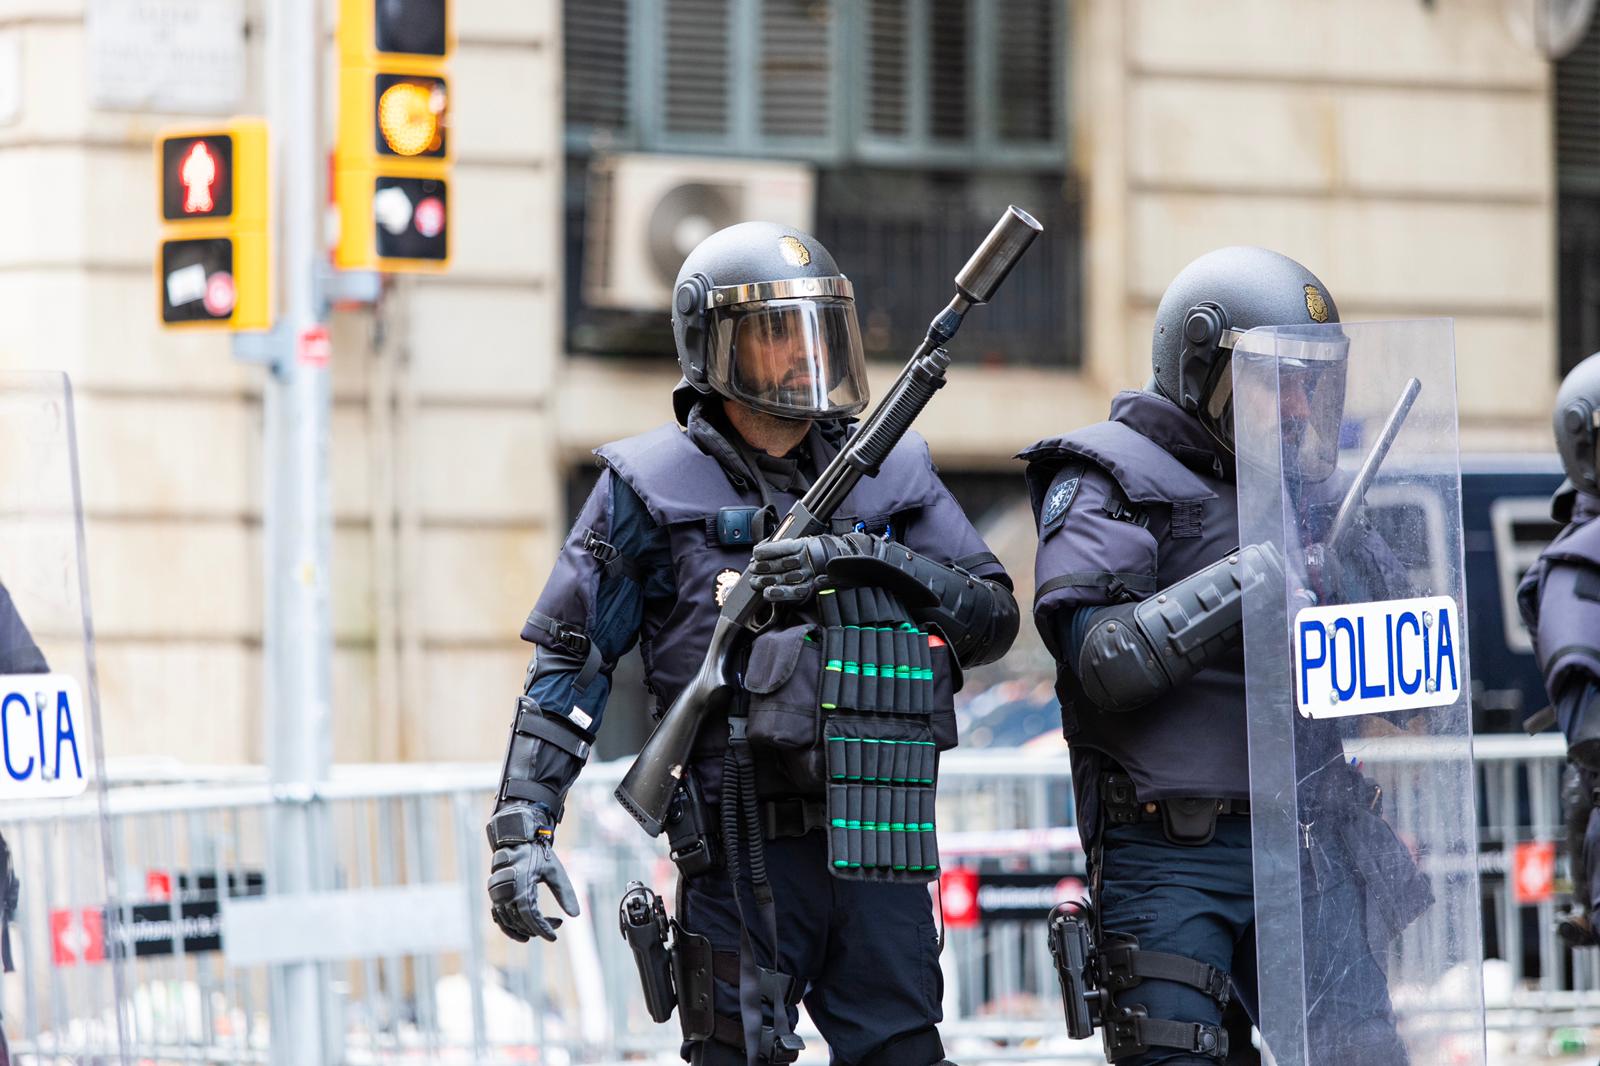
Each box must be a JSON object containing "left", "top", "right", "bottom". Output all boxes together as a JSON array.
[{"left": 1517, "top": 352, "right": 1600, "bottom": 946}]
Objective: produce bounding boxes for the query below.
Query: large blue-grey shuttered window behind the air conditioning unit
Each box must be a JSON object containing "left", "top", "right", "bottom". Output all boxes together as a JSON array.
[{"left": 565, "top": 0, "right": 1082, "bottom": 367}]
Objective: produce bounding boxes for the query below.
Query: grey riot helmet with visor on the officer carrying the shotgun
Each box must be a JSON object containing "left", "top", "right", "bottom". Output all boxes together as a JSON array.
[{"left": 672, "top": 222, "right": 867, "bottom": 423}]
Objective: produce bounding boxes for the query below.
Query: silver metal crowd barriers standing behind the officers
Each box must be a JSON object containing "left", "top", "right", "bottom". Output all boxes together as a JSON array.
[{"left": 0, "top": 736, "right": 1600, "bottom": 1066}]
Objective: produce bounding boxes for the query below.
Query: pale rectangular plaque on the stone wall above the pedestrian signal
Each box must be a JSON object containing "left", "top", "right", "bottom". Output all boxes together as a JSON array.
[{"left": 88, "top": 0, "right": 245, "bottom": 115}]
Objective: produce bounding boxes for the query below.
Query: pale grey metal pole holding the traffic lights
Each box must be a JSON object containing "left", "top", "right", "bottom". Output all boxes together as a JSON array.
[{"left": 264, "top": 0, "right": 331, "bottom": 1066}]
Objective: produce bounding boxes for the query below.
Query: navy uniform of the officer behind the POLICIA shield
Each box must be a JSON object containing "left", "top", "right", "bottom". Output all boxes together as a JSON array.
[{"left": 1021, "top": 392, "right": 1405, "bottom": 1064}]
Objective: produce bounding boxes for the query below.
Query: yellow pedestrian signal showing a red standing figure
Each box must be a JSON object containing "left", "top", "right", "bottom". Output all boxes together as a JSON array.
[{"left": 155, "top": 118, "right": 272, "bottom": 331}]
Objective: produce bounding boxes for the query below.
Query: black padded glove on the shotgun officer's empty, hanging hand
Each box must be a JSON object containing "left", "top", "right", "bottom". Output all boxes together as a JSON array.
[{"left": 488, "top": 804, "right": 578, "bottom": 943}]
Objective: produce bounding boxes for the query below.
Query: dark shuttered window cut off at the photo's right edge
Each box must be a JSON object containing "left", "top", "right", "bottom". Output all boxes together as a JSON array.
[{"left": 1555, "top": 18, "right": 1600, "bottom": 375}]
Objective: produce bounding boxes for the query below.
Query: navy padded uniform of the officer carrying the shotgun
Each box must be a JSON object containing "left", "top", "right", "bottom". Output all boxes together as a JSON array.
[{"left": 523, "top": 407, "right": 1005, "bottom": 1066}]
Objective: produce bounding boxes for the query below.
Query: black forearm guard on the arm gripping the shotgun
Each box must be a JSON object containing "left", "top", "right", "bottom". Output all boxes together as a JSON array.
[{"left": 827, "top": 538, "right": 1021, "bottom": 666}]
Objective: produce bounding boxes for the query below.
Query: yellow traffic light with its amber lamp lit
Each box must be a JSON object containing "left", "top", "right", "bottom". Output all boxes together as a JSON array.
[{"left": 333, "top": 0, "right": 453, "bottom": 272}]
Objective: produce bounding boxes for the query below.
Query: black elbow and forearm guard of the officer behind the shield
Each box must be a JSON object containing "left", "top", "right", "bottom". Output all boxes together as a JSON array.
[{"left": 1077, "top": 544, "right": 1283, "bottom": 711}]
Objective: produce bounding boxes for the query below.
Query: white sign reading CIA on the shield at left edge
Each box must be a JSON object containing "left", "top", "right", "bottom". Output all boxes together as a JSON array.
[{"left": 0, "top": 674, "right": 93, "bottom": 800}]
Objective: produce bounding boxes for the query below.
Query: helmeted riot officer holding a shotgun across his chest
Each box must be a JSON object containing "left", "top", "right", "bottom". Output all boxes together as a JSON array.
[{"left": 488, "top": 222, "right": 1018, "bottom": 1066}]
